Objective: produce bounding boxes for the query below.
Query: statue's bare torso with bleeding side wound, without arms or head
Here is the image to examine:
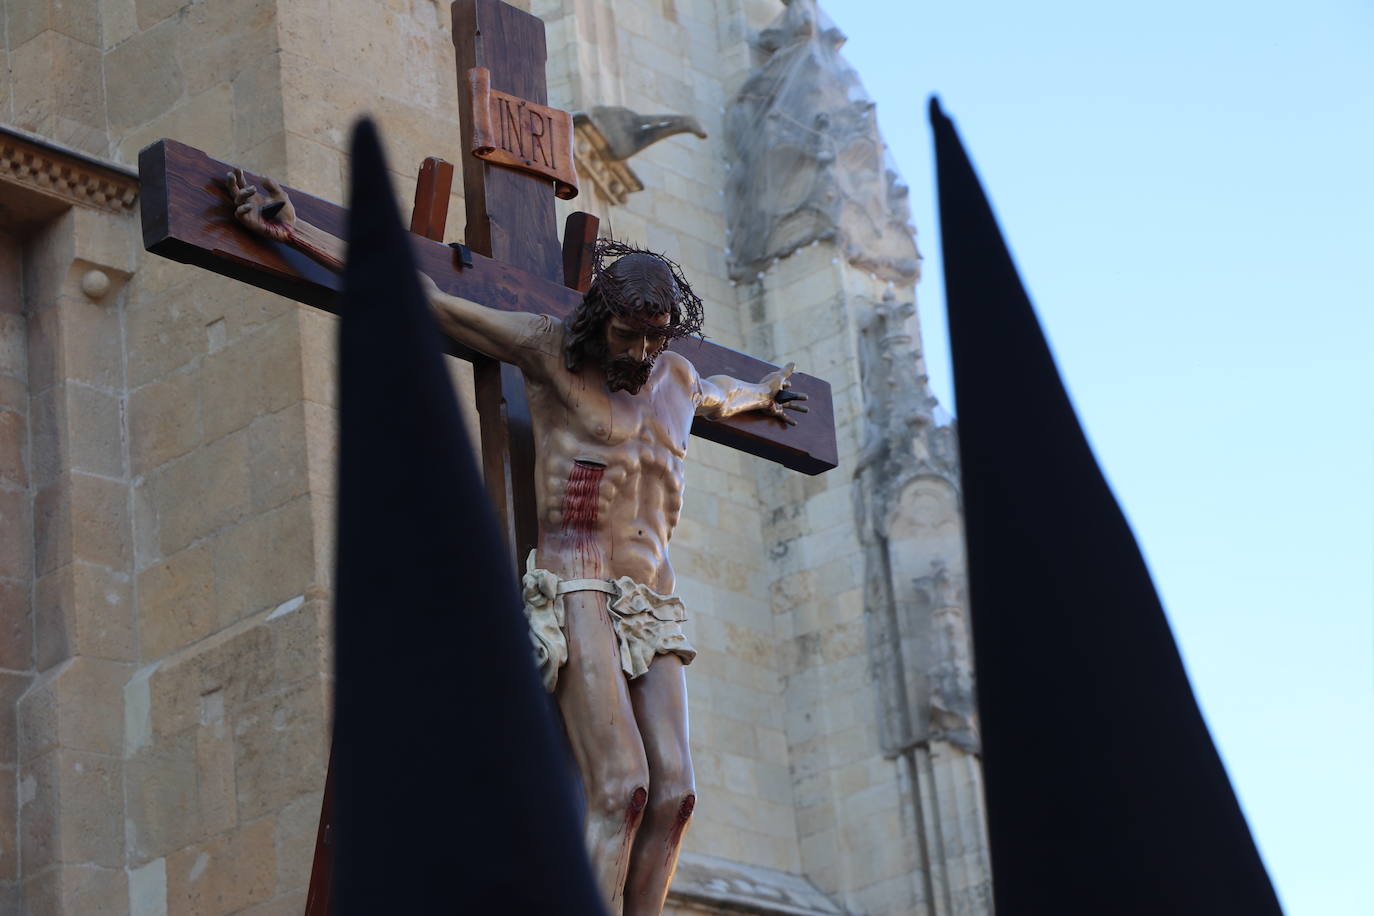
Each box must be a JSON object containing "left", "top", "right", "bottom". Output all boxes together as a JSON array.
[{"left": 528, "top": 323, "right": 698, "bottom": 593}]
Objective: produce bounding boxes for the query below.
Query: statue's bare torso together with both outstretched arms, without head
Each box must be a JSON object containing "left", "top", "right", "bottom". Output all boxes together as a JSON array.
[{"left": 225, "top": 170, "right": 807, "bottom": 593}]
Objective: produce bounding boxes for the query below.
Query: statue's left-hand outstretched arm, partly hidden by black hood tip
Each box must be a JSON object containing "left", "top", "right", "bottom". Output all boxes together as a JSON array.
[{"left": 225, "top": 169, "right": 554, "bottom": 369}]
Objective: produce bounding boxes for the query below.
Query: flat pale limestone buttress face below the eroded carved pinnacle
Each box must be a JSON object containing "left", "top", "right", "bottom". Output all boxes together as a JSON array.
[{"left": 741, "top": 243, "right": 932, "bottom": 913}]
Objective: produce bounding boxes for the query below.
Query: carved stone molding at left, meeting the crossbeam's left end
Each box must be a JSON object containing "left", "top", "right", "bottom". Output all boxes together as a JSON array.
[{"left": 0, "top": 126, "right": 139, "bottom": 214}]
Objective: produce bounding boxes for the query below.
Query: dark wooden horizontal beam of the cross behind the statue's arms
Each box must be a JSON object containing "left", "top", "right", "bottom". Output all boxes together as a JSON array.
[{"left": 139, "top": 140, "right": 838, "bottom": 474}]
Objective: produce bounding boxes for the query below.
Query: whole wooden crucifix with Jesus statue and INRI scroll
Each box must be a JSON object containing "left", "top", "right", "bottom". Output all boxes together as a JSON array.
[{"left": 140, "top": 0, "right": 835, "bottom": 913}]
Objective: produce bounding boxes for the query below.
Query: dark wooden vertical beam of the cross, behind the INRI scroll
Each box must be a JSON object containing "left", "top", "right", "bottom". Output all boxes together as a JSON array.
[{"left": 453, "top": 0, "right": 563, "bottom": 566}]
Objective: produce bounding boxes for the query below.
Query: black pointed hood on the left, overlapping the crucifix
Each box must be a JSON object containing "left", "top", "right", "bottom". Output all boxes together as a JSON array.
[{"left": 331, "top": 121, "right": 603, "bottom": 916}]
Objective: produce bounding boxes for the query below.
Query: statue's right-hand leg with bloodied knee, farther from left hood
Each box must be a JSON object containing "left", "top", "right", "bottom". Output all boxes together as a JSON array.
[{"left": 625, "top": 655, "right": 697, "bottom": 916}]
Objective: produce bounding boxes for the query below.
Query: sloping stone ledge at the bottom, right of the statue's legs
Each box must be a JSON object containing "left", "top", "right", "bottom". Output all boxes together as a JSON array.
[{"left": 668, "top": 853, "right": 845, "bottom": 916}]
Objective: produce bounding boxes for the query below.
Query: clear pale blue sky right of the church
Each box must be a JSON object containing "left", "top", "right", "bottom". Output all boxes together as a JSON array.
[{"left": 827, "top": 0, "right": 1374, "bottom": 916}]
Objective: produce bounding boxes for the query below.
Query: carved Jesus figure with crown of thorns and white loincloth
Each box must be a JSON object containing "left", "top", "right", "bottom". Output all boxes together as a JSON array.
[{"left": 227, "top": 172, "right": 807, "bottom": 916}]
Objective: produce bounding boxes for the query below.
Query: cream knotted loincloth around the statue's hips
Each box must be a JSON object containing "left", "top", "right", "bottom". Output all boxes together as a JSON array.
[{"left": 521, "top": 551, "right": 697, "bottom": 691}]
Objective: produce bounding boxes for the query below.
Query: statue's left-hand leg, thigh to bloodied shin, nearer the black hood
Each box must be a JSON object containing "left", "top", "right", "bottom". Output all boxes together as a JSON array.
[{"left": 555, "top": 592, "right": 649, "bottom": 916}]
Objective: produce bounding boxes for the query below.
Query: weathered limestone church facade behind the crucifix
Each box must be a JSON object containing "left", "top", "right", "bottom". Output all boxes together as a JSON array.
[{"left": 0, "top": 0, "right": 992, "bottom": 916}]
